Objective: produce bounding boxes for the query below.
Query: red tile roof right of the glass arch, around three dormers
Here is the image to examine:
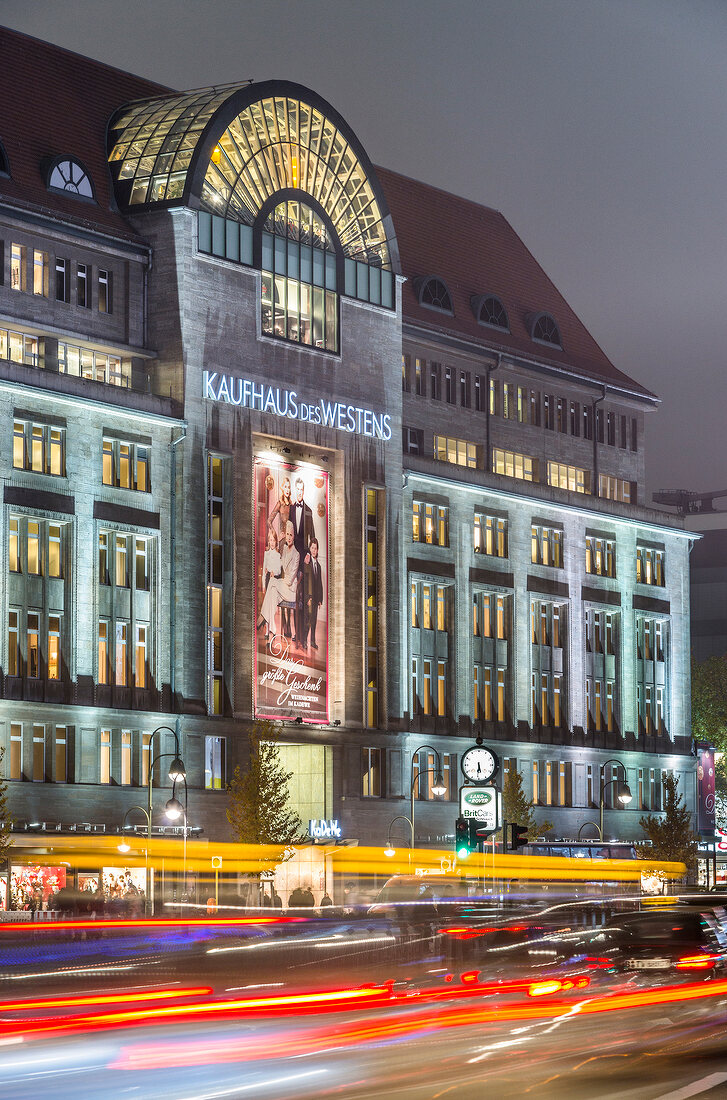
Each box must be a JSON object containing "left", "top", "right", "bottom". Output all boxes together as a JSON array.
[{"left": 376, "top": 167, "right": 654, "bottom": 400}]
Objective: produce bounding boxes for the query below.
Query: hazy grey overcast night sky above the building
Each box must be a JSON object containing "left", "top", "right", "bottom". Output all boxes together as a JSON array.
[{"left": 0, "top": 0, "right": 727, "bottom": 491}]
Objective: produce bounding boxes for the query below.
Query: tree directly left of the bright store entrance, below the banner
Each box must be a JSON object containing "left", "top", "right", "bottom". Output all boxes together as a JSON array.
[{"left": 227, "top": 718, "right": 304, "bottom": 862}]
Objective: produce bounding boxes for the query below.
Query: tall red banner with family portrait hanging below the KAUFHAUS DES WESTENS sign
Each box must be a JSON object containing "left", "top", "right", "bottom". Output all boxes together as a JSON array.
[{"left": 254, "top": 455, "right": 329, "bottom": 724}]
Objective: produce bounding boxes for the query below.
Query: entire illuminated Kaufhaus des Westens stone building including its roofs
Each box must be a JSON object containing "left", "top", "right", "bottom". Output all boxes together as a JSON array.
[{"left": 0, "top": 31, "right": 693, "bottom": 902}]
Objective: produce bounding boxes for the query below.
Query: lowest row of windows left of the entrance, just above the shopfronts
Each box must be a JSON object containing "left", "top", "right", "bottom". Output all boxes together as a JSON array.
[{"left": 3, "top": 722, "right": 227, "bottom": 791}]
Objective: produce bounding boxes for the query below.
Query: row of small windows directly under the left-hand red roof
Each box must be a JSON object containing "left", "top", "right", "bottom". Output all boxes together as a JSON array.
[{"left": 4, "top": 242, "right": 113, "bottom": 314}]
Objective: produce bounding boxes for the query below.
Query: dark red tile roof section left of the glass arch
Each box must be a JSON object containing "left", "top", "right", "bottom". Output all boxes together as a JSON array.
[{"left": 0, "top": 28, "right": 169, "bottom": 240}]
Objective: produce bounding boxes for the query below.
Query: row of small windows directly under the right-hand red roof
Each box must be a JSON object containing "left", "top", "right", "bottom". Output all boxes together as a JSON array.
[{"left": 401, "top": 355, "right": 638, "bottom": 451}]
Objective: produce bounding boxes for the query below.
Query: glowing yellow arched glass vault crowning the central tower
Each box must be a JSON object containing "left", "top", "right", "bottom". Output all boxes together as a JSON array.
[{"left": 109, "top": 81, "right": 397, "bottom": 268}]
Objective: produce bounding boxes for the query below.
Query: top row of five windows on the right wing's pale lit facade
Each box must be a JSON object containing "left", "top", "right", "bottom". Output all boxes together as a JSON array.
[{"left": 411, "top": 498, "right": 665, "bottom": 587}]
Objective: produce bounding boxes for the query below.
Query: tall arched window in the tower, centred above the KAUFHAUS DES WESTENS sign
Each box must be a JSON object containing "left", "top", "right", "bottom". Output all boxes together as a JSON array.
[{"left": 256, "top": 198, "right": 339, "bottom": 351}]
